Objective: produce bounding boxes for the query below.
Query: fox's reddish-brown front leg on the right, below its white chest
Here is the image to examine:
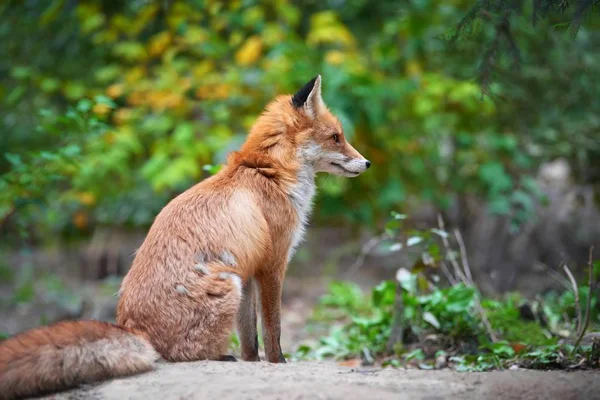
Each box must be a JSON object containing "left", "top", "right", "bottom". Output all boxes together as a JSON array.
[{"left": 257, "top": 271, "right": 286, "bottom": 363}]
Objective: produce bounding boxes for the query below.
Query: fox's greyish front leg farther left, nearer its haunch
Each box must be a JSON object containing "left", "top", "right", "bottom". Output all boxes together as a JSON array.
[{"left": 237, "top": 278, "right": 260, "bottom": 361}]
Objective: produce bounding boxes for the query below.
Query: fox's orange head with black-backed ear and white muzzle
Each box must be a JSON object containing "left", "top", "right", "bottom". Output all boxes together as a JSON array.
[{"left": 241, "top": 75, "right": 371, "bottom": 177}]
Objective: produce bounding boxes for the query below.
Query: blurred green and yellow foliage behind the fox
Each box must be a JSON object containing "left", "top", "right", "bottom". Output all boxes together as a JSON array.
[{"left": 0, "top": 0, "right": 600, "bottom": 244}]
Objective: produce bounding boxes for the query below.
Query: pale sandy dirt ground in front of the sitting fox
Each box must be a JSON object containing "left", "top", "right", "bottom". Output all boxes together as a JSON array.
[{"left": 47, "top": 361, "right": 600, "bottom": 400}]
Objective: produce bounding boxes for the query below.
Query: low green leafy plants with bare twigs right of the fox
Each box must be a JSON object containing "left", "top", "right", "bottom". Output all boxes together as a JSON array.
[{"left": 295, "top": 213, "right": 600, "bottom": 371}]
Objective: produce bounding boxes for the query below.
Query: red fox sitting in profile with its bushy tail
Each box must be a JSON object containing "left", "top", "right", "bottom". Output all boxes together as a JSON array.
[{"left": 0, "top": 75, "right": 371, "bottom": 399}]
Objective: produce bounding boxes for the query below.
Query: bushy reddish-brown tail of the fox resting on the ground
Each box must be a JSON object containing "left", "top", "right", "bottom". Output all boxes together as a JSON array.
[{"left": 0, "top": 321, "right": 159, "bottom": 400}]
